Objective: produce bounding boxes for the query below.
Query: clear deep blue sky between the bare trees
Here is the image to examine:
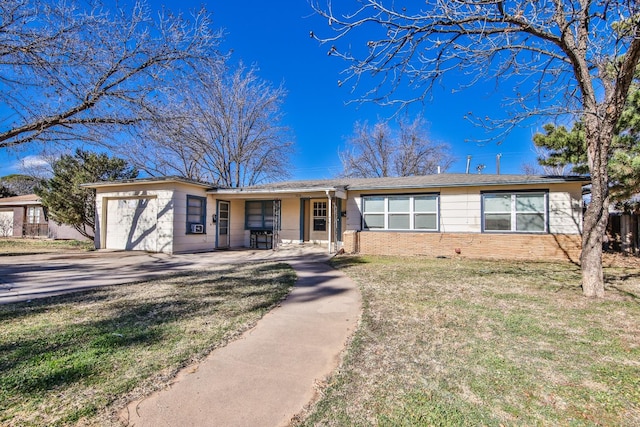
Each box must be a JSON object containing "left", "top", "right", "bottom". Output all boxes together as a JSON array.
[{"left": 0, "top": 0, "right": 539, "bottom": 179}]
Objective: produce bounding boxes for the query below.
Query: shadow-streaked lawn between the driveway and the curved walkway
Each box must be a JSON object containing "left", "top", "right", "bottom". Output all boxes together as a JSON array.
[{"left": 0, "top": 263, "right": 295, "bottom": 426}]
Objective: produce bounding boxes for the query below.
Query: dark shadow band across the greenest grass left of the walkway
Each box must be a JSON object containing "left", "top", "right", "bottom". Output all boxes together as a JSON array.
[{"left": 0, "top": 299, "right": 215, "bottom": 394}]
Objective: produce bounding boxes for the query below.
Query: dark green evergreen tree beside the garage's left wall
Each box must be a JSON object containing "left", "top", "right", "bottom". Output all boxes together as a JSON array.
[{"left": 36, "top": 149, "right": 138, "bottom": 239}]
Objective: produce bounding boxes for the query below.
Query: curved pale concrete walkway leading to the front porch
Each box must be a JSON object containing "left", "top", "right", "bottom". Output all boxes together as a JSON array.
[{"left": 121, "top": 255, "right": 361, "bottom": 427}]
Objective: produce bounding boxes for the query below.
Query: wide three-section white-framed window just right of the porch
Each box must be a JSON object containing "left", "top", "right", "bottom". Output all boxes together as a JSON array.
[{"left": 362, "top": 194, "right": 438, "bottom": 231}]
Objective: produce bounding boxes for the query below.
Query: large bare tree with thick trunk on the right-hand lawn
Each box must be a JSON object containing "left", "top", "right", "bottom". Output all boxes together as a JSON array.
[{"left": 312, "top": 0, "right": 640, "bottom": 297}]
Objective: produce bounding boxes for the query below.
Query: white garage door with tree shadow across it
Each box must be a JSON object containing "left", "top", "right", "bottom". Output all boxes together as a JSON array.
[{"left": 105, "top": 198, "right": 158, "bottom": 252}]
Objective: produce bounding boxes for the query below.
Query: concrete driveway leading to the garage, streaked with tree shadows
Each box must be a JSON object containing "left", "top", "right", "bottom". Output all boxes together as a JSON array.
[{"left": 0, "top": 245, "right": 329, "bottom": 304}]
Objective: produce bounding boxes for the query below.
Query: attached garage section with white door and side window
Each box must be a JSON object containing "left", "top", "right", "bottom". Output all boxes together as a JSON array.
[{"left": 83, "top": 177, "right": 217, "bottom": 254}]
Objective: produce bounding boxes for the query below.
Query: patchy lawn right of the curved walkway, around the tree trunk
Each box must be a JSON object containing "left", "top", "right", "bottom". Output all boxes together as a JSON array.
[{"left": 300, "top": 257, "right": 640, "bottom": 426}]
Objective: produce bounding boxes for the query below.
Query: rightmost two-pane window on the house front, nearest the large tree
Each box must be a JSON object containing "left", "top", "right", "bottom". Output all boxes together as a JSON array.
[{"left": 482, "top": 192, "right": 548, "bottom": 233}]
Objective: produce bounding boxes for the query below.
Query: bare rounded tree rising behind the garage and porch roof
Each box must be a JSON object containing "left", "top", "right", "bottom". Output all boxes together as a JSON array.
[{"left": 131, "top": 66, "right": 293, "bottom": 187}]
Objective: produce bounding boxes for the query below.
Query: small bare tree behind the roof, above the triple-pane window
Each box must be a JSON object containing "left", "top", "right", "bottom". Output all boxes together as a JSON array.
[{"left": 339, "top": 118, "right": 454, "bottom": 178}]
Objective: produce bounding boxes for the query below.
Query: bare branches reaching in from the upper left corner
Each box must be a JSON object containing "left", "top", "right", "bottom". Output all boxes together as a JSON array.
[{"left": 0, "top": 0, "right": 220, "bottom": 148}]
